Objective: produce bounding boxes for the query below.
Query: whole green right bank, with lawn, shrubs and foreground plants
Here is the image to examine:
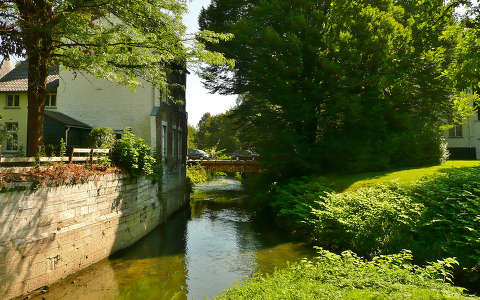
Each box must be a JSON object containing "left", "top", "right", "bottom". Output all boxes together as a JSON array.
[{"left": 220, "top": 161, "right": 480, "bottom": 299}]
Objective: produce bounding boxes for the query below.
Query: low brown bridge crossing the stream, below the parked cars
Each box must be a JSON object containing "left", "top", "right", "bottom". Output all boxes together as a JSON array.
[{"left": 187, "top": 160, "right": 260, "bottom": 173}]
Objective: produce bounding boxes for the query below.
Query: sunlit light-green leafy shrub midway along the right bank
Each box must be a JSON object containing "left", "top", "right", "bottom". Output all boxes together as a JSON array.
[{"left": 308, "top": 184, "right": 423, "bottom": 257}]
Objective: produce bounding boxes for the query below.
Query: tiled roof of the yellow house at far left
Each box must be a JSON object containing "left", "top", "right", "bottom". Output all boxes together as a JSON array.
[{"left": 0, "top": 60, "right": 60, "bottom": 92}]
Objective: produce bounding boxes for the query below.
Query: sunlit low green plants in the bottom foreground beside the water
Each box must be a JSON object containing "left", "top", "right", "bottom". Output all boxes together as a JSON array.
[{"left": 216, "top": 250, "right": 478, "bottom": 300}]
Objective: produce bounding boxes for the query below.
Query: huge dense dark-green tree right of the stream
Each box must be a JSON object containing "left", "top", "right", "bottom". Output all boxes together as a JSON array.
[{"left": 199, "top": 0, "right": 457, "bottom": 177}]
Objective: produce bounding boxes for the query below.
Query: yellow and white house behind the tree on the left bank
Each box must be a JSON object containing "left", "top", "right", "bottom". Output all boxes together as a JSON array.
[{"left": 0, "top": 59, "right": 187, "bottom": 164}]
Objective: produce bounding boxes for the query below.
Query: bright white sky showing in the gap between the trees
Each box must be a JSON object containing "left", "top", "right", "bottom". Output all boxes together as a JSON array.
[{"left": 183, "top": 0, "right": 237, "bottom": 125}]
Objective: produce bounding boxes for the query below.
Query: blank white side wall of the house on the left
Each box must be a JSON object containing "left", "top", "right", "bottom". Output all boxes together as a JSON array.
[{"left": 57, "top": 69, "right": 158, "bottom": 148}]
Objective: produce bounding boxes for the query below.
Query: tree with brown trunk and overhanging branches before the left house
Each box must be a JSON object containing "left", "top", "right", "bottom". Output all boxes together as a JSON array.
[{"left": 0, "top": 0, "right": 232, "bottom": 155}]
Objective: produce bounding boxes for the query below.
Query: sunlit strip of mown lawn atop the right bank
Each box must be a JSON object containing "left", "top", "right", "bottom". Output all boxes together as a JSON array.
[{"left": 319, "top": 160, "right": 480, "bottom": 192}]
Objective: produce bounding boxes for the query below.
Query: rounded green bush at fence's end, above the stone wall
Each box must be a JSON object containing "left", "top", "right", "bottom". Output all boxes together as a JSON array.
[{"left": 113, "top": 127, "right": 156, "bottom": 176}]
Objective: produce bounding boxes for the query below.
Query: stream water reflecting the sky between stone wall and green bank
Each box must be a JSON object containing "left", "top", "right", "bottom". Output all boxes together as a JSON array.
[{"left": 38, "top": 179, "right": 313, "bottom": 300}]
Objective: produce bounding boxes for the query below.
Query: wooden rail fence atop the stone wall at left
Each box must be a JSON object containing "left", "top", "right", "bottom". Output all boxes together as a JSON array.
[{"left": 0, "top": 148, "right": 110, "bottom": 164}]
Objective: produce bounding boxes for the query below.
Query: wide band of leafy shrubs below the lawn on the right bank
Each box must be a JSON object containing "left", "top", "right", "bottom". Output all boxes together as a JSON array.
[{"left": 271, "top": 167, "right": 480, "bottom": 268}]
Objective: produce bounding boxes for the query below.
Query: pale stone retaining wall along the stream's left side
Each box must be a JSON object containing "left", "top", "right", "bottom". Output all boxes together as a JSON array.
[{"left": 0, "top": 172, "right": 185, "bottom": 299}]
